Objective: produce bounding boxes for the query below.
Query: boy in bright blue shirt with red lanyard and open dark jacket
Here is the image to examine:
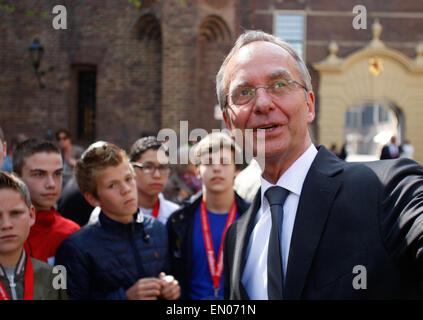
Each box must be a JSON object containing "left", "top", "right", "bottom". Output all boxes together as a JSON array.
[{"left": 167, "top": 133, "right": 249, "bottom": 300}]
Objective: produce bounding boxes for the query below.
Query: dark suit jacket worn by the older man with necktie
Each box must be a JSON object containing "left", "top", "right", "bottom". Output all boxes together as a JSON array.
[{"left": 224, "top": 147, "right": 423, "bottom": 299}]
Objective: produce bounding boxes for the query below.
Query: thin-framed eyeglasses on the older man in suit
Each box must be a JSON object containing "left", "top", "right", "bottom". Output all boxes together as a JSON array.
[{"left": 226, "top": 79, "right": 307, "bottom": 107}]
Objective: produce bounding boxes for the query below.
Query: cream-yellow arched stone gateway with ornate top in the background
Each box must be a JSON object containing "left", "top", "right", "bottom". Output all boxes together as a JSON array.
[{"left": 313, "top": 22, "right": 423, "bottom": 163}]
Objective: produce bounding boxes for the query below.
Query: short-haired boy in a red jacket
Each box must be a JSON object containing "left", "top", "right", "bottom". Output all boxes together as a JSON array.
[{"left": 13, "top": 139, "right": 80, "bottom": 265}]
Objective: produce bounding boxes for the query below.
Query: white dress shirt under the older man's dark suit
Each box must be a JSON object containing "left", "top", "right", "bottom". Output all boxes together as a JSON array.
[{"left": 241, "top": 144, "right": 317, "bottom": 300}]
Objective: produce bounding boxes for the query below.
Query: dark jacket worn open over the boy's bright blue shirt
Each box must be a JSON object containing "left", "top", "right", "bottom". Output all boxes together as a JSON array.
[{"left": 167, "top": 192, "right": 250, "bottom": 300}]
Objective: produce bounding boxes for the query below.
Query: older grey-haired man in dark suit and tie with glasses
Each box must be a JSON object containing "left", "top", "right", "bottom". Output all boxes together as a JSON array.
[{"left": 216, "top": 31, "right": 423, "bottom": 300}]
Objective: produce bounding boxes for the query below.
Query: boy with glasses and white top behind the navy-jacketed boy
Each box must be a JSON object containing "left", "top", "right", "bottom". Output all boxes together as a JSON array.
[{"left": 90, "top": 136, "right": 179, "bottom": 224}]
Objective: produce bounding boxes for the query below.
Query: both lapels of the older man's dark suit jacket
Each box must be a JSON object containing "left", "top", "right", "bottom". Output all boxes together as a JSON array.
[{"left": 231, "top": 146, "right": 344, "bottom": 299}]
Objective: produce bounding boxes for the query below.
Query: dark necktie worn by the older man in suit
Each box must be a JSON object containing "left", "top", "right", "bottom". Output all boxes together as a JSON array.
[{"left": 264, "top": 186, "right": 289, "bottom": 300}]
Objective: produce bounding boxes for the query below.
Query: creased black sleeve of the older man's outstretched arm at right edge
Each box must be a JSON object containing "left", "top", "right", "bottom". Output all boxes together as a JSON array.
[{"left": 376, "top": 159, "right": 423, "bottom": 278}]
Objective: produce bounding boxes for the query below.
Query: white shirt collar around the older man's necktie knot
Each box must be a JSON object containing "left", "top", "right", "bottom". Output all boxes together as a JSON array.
[{"left": 260, "top": 144, "right": 317, "bottom": 205}]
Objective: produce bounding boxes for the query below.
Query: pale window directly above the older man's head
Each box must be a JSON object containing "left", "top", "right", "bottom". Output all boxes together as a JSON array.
[{"left": 275, "top": 13, "right": 305, "bottom": 59}]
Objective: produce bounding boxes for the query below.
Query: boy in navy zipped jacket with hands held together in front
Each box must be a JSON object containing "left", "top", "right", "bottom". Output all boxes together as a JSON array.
[{"left": 53, "top": 141, "right": 180, "bottom": 300}]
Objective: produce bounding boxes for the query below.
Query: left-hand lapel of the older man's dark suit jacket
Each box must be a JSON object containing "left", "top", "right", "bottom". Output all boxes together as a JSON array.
[{"left": 231, "top": 189, "right": 261, "bottom": 299}]
